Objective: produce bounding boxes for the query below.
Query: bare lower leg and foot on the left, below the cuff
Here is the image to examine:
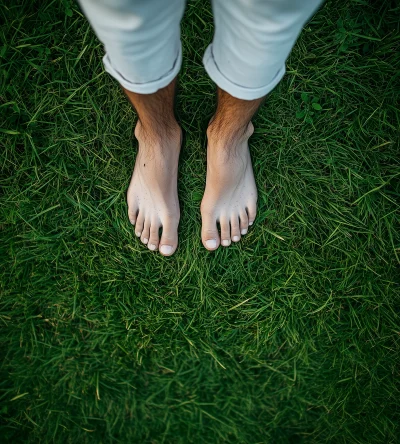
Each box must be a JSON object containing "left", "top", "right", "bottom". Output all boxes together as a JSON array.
[{"left": 125, "top": 80, "right": 182, "bottom": 256}]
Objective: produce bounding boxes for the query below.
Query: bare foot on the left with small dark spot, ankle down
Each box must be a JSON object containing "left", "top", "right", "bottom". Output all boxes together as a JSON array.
[{"left": 127, "top": 121, "right": 182, "bottom": 256}]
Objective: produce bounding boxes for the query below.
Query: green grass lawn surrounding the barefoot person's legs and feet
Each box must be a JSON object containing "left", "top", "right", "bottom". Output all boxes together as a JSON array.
[{"left": 0, "top": 0, "right": 400, "bottom": 444}]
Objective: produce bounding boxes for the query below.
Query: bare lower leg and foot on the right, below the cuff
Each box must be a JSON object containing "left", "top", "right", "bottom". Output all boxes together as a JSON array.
[{"left": 201, "top": 89, "right": 263, "bottom": 250}]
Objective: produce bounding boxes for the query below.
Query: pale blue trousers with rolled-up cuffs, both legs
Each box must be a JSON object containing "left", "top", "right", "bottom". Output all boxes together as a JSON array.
[{"left": 80, "top": 0, "right": 322, "bottom": 100}]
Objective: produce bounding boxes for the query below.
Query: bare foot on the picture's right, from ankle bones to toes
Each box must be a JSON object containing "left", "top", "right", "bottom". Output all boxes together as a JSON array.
[{"left": 201, "top": 122, "right": 257, "bottom": 250}]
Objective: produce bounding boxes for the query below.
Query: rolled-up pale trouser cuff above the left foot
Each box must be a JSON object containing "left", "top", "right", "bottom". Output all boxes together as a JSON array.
[{"left": 103, "top": 46, "right": 182, "bottom": 94}]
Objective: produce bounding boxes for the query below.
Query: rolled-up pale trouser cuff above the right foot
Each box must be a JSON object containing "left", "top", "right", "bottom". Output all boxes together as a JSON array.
[{"left": 203, "top": 44, "right": 286, "bottom": 100}]
